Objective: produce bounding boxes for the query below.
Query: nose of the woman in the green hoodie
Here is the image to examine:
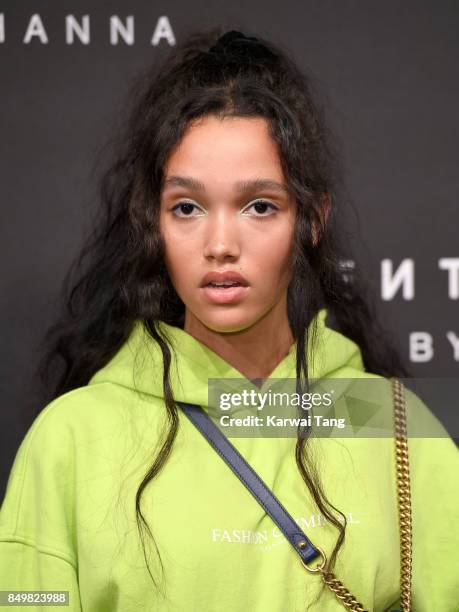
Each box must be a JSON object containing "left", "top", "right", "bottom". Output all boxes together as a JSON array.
[{"left": 204, "top": 210, "right": 240, "bottom": 261}]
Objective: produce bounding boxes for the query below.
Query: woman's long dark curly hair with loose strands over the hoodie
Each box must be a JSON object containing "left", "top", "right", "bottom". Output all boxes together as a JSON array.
[{"left": 39, "top": 29, "right": 407, "bottom": 604}]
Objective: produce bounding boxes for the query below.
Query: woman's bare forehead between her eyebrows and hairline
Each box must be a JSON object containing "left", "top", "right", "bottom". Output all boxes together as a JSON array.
[{"left": 165, "top": 116, "right": 283, "bottom": 180}]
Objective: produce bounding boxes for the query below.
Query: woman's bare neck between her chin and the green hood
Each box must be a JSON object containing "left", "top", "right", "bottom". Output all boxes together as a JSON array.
[{"left": 184, "top": 301, "right": 294, "bottom": 380}]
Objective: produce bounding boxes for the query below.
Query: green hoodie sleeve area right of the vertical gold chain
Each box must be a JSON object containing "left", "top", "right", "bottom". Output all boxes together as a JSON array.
[{"left": 406, "top": 390, "right": 459, "bottom": 612}]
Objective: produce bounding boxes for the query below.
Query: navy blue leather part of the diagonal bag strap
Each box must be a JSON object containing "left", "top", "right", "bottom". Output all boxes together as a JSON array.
[{"left": 177, "top": 402, "right": 322, "bottom": 563}]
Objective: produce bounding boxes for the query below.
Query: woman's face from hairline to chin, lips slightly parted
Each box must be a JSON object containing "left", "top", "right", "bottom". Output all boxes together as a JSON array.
[{"left": 160, "top": 116, "right": 296, "bottom": 332}]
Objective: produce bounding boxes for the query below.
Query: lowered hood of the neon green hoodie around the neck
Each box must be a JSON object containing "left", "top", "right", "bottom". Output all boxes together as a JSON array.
[{"left": 89, "top": 308, "right": 365, "bottom": 407}]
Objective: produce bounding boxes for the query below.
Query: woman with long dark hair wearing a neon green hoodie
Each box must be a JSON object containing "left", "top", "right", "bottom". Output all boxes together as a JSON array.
[{"left": 0, "top": 31, "right": 459, "bottom": 612}]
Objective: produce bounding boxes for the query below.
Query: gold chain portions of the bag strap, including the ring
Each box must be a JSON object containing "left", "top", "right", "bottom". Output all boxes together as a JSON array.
[{"left": 301, "top": 378, "right": 412, "bottom": 612}]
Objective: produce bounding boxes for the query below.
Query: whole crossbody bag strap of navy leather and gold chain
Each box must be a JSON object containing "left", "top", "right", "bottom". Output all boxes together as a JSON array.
[{"left": 177, "top": 378, "right": 412, "bottom": 612}]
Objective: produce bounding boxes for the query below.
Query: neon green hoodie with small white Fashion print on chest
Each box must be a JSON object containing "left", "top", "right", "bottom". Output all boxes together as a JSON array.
[{"left": 0, "top": 310, "right": 459, "bottom": 612}]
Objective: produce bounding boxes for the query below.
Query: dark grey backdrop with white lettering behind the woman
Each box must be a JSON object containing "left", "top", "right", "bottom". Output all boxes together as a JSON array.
[{"left": 0, "top": 0, "right": 459, "bottom": 495}]
